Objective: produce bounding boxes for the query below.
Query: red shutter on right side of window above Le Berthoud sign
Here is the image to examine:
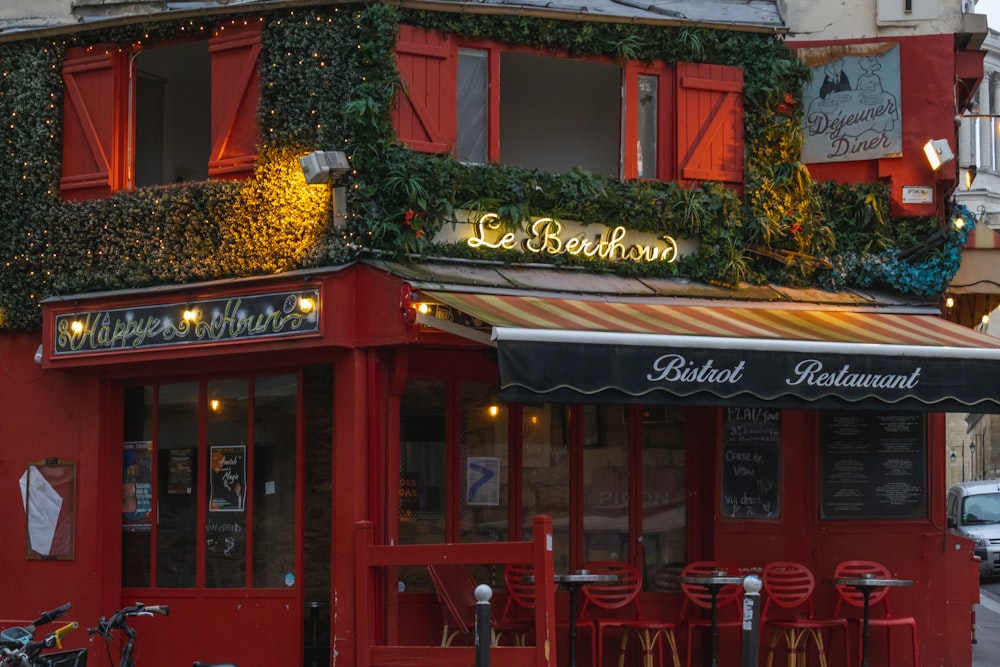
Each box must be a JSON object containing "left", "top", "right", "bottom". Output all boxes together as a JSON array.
[{"left": 677, "top": 63, "right": 744, "bottom": 186}]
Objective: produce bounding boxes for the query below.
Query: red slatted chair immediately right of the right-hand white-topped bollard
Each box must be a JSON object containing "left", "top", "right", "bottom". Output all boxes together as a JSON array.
[{"left": 761, "top": 561, "right": 851, "bottom": 667}]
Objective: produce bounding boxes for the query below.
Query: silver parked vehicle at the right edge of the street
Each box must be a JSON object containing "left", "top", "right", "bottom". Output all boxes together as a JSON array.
[{"left": 947, "top": 479, "right": 1000, "bottom": 578}]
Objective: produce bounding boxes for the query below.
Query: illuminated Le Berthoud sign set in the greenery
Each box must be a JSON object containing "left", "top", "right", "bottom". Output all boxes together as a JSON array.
[{"left": 434, "top": 211, "right": 697, "bottom": 264}]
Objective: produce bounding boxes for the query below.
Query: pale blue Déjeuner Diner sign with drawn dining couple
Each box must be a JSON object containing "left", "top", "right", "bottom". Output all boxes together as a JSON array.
[{"left": 798, "top": 42, "right": 903, "bottom": 163}]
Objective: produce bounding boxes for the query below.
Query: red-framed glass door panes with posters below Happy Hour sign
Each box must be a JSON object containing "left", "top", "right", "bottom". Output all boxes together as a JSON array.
[{"left": 122, "top": 373, "right": 301, "bottom": 589}]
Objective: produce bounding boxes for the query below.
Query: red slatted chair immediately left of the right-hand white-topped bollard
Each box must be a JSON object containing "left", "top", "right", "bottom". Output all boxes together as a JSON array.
[{"left": 680, "top": 560, "right": 743, "bottom": 667}]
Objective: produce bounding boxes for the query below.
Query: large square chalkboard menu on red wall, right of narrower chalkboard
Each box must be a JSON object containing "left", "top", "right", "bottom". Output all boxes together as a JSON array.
[{"left": 820, "top": 411, "right": 927, "bottom": 519}]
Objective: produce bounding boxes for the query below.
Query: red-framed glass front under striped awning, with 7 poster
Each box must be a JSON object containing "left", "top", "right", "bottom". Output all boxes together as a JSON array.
[{"left": 399, "top": 381, "right": 686, "bottom": 590}]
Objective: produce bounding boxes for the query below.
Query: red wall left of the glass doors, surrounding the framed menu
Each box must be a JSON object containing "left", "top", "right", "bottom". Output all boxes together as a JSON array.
[{"left": 0, "top": 334, "right": 110, "bottom": 646}]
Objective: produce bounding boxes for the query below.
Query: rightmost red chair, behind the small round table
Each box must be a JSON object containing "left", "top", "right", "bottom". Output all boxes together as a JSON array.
[{"left": 833, "top": 560, "right": 920, "bottom": 667}]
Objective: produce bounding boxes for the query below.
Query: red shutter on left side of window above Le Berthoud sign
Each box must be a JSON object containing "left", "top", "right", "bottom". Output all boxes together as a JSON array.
[{"left": 392, "top": 25, "right": 458, "bottom": 153}]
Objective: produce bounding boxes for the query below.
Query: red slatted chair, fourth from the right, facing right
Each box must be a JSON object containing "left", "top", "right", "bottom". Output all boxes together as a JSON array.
[{"left": 577, "top": 561, "right": 681, "bottom": 667}]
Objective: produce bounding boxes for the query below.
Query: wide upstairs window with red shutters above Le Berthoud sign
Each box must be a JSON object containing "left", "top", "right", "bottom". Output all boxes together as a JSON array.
[{"left": 393, "top": 26, "right": 744, "bottom": 187}]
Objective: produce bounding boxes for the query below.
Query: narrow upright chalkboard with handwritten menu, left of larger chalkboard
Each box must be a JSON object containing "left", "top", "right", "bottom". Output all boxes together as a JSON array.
[{"left": 721, "top": 408, "right": 781, "bottom": 519}]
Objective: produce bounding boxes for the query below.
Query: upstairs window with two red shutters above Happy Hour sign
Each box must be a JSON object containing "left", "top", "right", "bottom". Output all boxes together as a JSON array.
[{"left": 60, "top": 25, "right": 260, "bottom": 200}]
